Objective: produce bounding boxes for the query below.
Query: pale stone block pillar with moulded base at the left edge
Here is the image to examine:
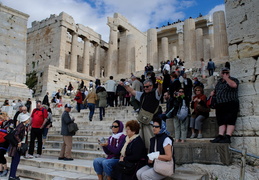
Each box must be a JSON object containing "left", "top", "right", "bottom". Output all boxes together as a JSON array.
[{"left": 0, "top": 3, "right": 31, "bottom": 100}]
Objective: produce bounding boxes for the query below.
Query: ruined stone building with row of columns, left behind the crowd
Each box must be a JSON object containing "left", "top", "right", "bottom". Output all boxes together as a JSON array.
[{"left": 26, "top": 12, "right": 108, "bottom": 96}]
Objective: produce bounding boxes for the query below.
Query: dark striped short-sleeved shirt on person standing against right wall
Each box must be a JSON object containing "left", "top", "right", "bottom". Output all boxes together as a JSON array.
[{"left": 215, "top": 77, "right": 239, "bottom": 104}]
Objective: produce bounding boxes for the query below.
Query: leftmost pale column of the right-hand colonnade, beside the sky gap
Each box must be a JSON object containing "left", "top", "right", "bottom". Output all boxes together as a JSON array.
[{"left": 147, "top": 28, "right": 159, "bottom": 69}]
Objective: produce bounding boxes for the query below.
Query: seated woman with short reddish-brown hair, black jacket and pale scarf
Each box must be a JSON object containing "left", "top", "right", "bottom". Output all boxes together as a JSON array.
[{"left": 115, "top": 120, "right": 146, "bottom": 180}]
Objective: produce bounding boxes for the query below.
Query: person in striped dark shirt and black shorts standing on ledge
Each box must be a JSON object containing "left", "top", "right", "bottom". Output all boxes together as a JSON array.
[{"left": 210, "top": 67, "right": 239, "bottom": 143}]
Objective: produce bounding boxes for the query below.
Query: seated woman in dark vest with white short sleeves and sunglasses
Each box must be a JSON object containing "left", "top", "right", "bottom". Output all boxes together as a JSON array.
[{"left": 137, "top": 118, "right": 173, "bottom": 180}]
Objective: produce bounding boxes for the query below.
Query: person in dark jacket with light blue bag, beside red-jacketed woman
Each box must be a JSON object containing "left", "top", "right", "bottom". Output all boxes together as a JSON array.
[{"left": 172, "top": 88, "right": 190, "bottom": 143}]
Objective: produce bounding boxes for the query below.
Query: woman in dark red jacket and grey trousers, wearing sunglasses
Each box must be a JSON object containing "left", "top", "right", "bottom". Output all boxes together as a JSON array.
[{"left": 190, "top": 86, "right": 209, "bottom": 139}]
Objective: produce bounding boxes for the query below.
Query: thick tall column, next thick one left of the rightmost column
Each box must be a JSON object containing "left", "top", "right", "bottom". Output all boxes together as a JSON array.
[{"left": 184, "top": 18, "right": 197, "bottom": 68}]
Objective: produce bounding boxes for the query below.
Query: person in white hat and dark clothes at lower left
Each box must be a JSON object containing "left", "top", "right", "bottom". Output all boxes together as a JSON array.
[{"left": 8, "top": 114, "right": 30, "bottom": 180}]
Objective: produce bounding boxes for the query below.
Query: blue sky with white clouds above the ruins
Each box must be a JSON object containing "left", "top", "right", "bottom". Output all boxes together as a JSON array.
[{"left": 0, "top": 0, "right": 224, "bottom": 41}]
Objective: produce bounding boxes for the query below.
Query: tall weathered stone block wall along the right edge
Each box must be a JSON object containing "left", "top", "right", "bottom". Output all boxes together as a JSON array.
[{"left": 225, "top": 0, "right": 259, "bottom": 156}]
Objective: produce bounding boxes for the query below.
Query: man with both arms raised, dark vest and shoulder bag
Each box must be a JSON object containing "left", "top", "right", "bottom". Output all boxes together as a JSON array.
[{"left": 121, "top": 76, "right": 163, "bottom": 149}]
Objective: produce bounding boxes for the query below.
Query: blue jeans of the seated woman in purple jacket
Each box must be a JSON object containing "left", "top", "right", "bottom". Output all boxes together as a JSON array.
[{"left": 93, "top": 158, "right": 119, "bottom": 176}]
